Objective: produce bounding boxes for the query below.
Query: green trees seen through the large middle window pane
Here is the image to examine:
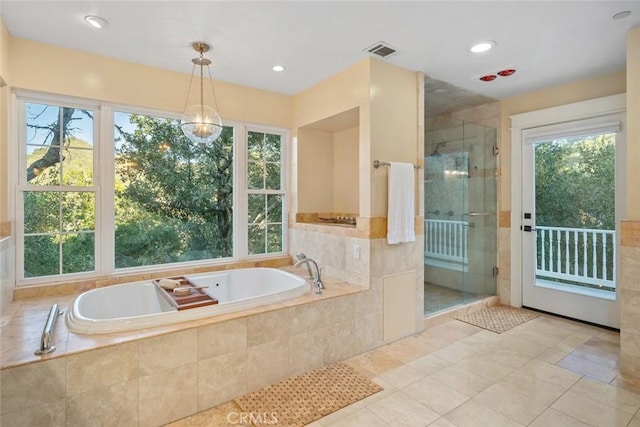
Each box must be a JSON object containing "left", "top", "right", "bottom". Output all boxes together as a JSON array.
[{"left": 115, "top": 114, "right": 233, "bottom": 267}]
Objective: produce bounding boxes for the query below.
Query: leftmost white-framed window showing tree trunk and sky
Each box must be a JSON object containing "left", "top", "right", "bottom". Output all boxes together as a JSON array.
[{"left": 20, "top": 103, "right": 96, "bottom": 278}]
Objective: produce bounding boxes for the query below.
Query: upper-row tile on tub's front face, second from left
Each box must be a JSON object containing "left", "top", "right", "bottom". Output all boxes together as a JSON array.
[{"left": 66, "top": 342, "right": 138, "bottom": 396}]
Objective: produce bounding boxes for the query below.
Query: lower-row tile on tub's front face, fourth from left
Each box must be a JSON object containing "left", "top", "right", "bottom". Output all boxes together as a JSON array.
[{"left": 198, "top": 349, "right": 247, "bottom": 411}]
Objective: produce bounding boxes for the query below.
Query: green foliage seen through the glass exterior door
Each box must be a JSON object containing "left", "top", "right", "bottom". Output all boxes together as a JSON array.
[{"left": 535, "top": 134, "right": 615, "bottom": 230}]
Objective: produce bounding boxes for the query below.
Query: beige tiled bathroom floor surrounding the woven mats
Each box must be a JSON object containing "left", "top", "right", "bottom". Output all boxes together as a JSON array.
[{"left": 171, "top": 315, "right": 640, "bottom": 427}]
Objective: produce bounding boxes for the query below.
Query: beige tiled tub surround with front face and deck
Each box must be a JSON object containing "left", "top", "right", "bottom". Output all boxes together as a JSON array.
[{"left": 0, "top": 267, "right": 382, "bottom": 426}]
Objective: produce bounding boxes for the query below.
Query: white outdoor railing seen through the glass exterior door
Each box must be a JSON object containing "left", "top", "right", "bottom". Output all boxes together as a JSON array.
[{"left": 536, "top": 225, "right": 616, "bottom": 288}]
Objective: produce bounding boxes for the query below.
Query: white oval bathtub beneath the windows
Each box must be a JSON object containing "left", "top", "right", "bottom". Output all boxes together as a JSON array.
[{"left": 65, "top": 268, "right": 310, "bottom": 334}]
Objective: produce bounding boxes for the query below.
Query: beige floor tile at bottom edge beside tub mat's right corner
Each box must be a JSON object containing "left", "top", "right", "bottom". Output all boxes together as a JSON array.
[{"left": 367, "top": 391, "right": 440, "bottom": 427}]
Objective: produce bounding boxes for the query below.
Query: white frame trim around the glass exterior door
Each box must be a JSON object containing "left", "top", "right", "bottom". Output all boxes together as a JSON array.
[{"left": 510, "top": 94, "right": 626, "bottom": 307}]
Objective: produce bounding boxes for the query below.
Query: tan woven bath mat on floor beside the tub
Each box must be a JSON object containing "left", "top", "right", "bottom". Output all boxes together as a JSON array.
[{"left": 235, "top": 362, "right": 382, "bottom": 427}]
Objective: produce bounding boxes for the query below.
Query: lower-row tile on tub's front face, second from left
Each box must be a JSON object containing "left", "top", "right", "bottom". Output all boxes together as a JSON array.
[{"left": 66, "top": 379, "right": 138, "bottom": 427}]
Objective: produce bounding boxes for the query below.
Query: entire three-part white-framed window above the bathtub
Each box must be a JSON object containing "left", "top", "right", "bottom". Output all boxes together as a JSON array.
[{"left": 17, "top": 96, "right": 286, "bottom": 284}]
